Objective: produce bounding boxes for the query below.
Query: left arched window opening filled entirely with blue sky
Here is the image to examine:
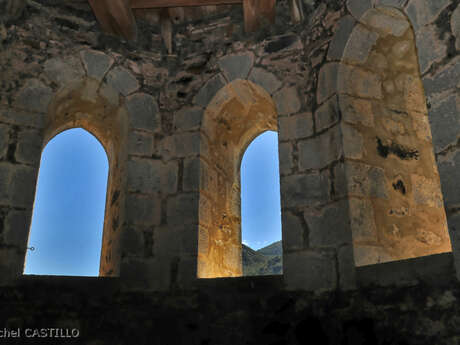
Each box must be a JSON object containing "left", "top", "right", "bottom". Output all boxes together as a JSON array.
[{"left": 24, "top": 128, "right": 109, "bottom": 276}]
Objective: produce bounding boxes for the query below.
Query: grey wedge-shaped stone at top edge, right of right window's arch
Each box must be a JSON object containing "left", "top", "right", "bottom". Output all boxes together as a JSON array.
[{"left": 406, "top": 0, "right": 451, "bottom": 30}]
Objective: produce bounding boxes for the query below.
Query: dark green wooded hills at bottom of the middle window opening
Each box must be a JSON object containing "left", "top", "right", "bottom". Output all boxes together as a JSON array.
[{"left": 242, "top": 241, "right": 283, "bottom": 276}]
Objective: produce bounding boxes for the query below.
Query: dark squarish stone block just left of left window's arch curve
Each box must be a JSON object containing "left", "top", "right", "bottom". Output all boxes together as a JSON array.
[{"left": 15, "top": 130, "right": 43, "bottom": 164}]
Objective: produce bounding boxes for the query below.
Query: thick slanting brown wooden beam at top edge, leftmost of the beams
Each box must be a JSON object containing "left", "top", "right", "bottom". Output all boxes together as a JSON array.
[{"left": 88, "top": 0, "right": 137, "bottom": 41}]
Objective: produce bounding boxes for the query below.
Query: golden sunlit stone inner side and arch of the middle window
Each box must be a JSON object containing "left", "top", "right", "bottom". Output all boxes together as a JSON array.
[{"left": 198, "top": 79, "right": 277, "bottom": 278}]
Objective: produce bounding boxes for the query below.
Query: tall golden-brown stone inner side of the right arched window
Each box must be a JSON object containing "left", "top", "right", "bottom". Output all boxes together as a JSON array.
[{"left": 338, "top": 8, "right": 451, "bottom": 266}]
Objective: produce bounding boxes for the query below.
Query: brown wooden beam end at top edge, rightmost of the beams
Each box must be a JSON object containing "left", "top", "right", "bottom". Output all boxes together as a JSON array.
[{"left": 243, "top": 0, "right": 276, "bottom": 32}]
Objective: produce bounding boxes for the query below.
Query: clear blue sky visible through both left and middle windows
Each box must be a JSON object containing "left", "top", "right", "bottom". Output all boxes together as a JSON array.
[{"left": 24, "top": 128, "right": 281, "bottom": 276}]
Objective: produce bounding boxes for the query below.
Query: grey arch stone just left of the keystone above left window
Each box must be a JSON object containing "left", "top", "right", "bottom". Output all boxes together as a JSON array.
[{"left": 44, "top": 56, "right": 85, "bottom": 86}]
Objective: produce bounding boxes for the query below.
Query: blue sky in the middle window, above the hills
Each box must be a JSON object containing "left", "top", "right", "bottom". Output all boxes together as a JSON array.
[{"left": 240, "top": 131, "right": 281, "bottom": 250}]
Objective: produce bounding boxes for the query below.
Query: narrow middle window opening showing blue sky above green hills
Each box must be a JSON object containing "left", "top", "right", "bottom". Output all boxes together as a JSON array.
[{"left": 240, "top": 131, "right": 283, "bottom": 275}]
